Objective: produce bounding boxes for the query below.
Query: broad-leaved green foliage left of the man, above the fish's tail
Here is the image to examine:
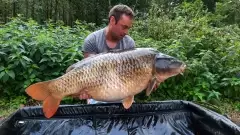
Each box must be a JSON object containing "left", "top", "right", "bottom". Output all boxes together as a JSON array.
[{"left": 0, "top": 17, "right": 91, "bottom": 96}]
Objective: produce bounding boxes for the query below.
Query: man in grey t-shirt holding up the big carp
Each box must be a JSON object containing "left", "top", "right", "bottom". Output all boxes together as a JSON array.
[{"left": 79, "top": 4, "right": 135, "bottom": 104}]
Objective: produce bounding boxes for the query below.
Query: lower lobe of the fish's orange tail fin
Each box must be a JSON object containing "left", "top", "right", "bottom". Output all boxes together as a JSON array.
[{"left": 43, "top": 96, "right": 61, "bottom": 118}]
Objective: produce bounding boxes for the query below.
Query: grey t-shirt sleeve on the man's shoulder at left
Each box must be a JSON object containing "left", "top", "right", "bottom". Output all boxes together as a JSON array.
[{"left": 82, "top": 34, "right": 98, "bottom": 53}]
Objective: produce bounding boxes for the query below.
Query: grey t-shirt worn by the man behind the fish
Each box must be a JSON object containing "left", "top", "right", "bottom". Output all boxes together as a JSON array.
[{"left": 82, "top": 28, "right": 135, "bottom": 53}]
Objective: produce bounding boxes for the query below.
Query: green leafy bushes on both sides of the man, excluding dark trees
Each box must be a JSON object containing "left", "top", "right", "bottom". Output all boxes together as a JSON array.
[{"left": 0, "top": 0, "right": 240, "bottom": 109}]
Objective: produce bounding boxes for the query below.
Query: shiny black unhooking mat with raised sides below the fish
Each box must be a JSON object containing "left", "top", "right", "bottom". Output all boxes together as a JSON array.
[{"left": 0, "top": 100, "right": 240, "bottom": 135}]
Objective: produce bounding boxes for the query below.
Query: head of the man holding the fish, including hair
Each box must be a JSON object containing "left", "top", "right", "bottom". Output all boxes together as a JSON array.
[{"left": 108, "top": 4, "right": 134, "bottom": 40}]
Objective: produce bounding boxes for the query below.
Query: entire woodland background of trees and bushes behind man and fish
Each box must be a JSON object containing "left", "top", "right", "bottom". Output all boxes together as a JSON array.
[{"left": 0, "top": 0, "right": 240, "bottom": 122}]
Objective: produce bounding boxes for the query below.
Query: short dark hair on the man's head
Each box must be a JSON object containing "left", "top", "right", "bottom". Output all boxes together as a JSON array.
[{"left": 108, "top": 4, "right": 134, "bottom": 23}]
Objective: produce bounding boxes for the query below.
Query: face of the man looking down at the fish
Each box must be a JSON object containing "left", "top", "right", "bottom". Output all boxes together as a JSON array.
[{"left": 110, "top": 14, "right": 133, "bottom": 40}]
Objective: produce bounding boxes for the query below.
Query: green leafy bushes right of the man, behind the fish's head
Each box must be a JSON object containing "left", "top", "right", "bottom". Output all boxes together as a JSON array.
[{"left": 131, "top": 0, "right": 240, "bottom": 104}]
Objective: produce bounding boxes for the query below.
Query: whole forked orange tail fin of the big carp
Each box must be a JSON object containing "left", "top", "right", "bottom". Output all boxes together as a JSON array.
[{"left": 26, "top": 81, "right": 61, "bottom": 118}]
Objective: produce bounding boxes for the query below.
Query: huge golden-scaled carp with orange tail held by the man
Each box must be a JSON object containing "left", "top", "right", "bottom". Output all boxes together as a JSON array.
[{"left": 26, "top": 48, "right": 186, "bottom": 118}]
